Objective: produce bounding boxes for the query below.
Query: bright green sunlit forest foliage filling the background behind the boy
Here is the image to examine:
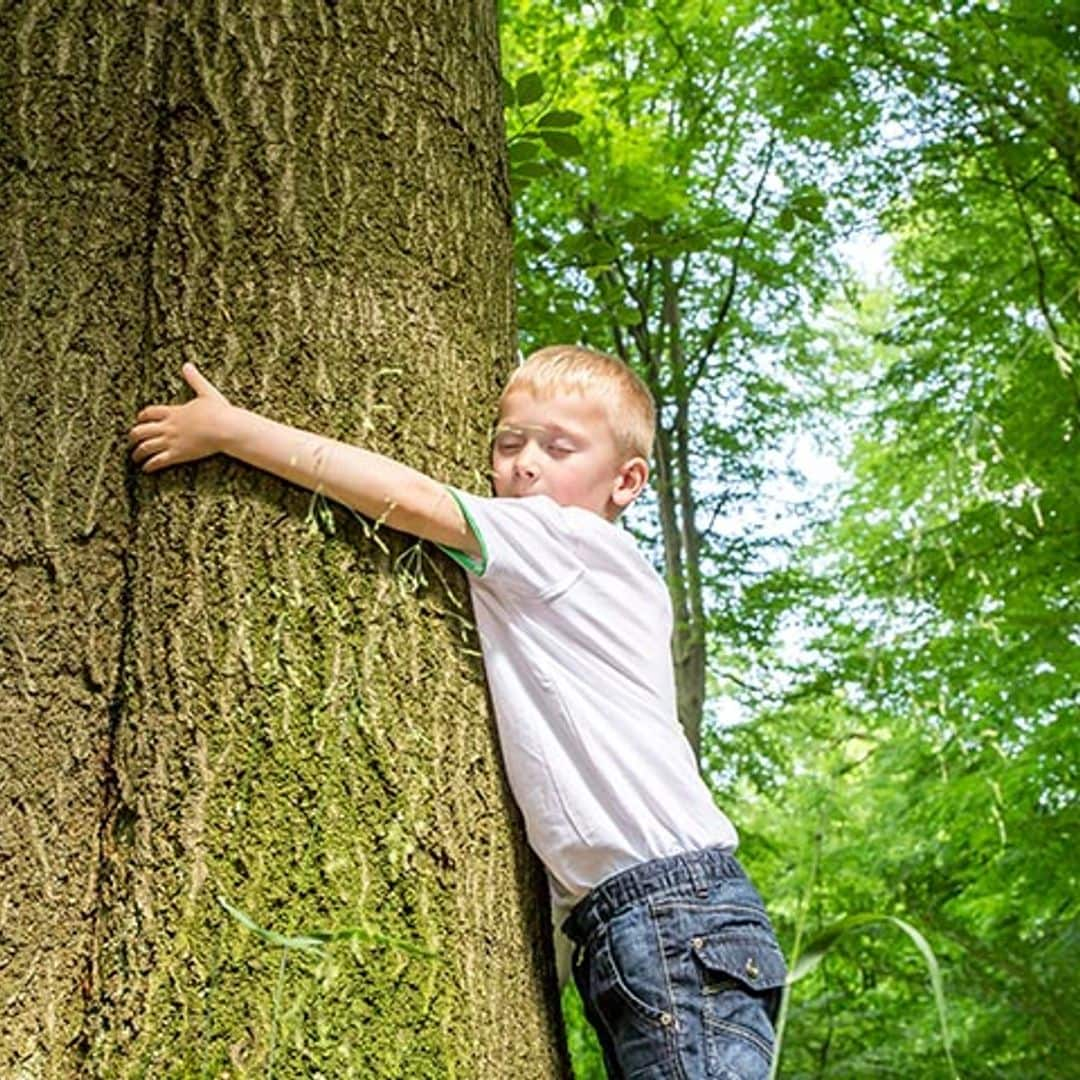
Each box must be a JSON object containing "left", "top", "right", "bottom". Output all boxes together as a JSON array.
[{"left": 505, "top": 0, "right": 1080, "bottom": 1078}]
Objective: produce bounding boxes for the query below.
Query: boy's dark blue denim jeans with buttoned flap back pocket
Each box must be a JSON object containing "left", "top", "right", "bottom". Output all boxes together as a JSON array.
[{"left": 563, "top": 848, "right": 786, "bottom": 1080}]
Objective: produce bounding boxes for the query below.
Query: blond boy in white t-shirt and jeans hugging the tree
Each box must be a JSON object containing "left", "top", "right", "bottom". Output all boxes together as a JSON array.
[{"left": 130, "top": 347, "right": 785, "bottom": 1080}]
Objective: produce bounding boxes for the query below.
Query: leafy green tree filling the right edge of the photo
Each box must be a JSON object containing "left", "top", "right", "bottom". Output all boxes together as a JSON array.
[{"left": 717, "top": 3, "right": 1080, "bottom": 1077}]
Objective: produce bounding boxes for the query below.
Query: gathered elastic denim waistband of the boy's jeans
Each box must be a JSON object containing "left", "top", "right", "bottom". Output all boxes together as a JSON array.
[{"left": 563, "top": 847, "right": 746, "bottom": 945}]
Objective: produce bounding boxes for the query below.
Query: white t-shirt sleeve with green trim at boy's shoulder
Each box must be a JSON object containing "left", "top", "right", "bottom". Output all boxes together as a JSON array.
[{"left": 443, "top": 488, "right": 584, "bottom": 599}]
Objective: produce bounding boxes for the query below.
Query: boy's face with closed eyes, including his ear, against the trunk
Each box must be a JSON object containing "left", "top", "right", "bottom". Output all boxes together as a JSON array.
[{"left": 491, "top": 389, "right": 648, "bottom": 521}]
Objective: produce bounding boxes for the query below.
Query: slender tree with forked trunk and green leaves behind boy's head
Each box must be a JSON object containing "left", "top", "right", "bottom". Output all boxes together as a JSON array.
[{"left": 503, "top": 2, "right": 872, "bottom": 750}]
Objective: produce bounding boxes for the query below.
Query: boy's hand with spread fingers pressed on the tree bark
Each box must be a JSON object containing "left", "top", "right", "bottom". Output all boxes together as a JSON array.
[{"left": 127, "top": 364, "right": 231, "bottom": 472}]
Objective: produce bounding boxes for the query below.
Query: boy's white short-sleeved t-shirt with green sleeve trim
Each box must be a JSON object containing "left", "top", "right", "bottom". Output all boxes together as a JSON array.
[{"left": 449, "top": 491, "right": 738, "bottom": 906}]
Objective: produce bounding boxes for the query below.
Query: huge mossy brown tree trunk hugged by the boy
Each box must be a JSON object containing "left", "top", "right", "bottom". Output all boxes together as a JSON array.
[{"left": 0, "top": 0, "right": 564, "bottom": 1078}]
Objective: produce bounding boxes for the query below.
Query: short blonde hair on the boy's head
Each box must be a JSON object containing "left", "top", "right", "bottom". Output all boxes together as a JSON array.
[{"left": 502, "top": 345, "right": 657, "bottom": 461}]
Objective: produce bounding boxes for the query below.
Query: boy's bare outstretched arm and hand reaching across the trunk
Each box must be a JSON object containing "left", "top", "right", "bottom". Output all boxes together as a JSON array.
[{"left": 129, "top": 364, "right": 481, "bottom": 558}]
